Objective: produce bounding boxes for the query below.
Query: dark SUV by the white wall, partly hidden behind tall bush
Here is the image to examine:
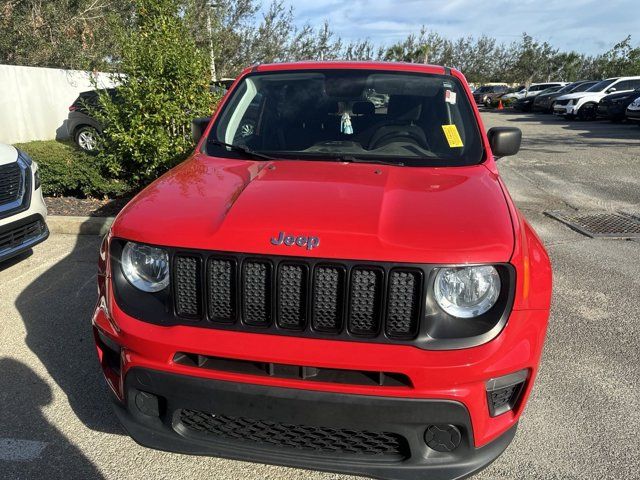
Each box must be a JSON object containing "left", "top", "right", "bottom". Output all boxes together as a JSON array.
[{"left": 67, "top": 88, "right": 116, "bottom": 152}]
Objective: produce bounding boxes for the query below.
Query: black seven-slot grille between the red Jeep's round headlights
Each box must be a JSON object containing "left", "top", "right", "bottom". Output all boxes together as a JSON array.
[{"left": 172, "top": 252, "right": 425, "bottom": 341}]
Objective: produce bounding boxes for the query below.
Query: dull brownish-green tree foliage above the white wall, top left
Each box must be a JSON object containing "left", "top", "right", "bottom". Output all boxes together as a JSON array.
[{"left": 0, "top": 0, "right": 131, "bottom": 70}]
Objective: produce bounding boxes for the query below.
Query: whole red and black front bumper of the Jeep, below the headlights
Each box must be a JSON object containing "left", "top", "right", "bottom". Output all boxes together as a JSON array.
[{"left": 93, "top": 275, "right": 549, "bottom": 479}]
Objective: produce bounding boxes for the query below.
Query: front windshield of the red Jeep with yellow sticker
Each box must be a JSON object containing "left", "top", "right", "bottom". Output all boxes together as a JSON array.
[{"left": 206, "top": 69, "right": 483, "bottom": 166}]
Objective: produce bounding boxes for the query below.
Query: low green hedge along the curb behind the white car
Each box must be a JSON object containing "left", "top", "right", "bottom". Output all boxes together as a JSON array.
[{"left": 16, "top": 140, "right": 129, "bottom": 198}]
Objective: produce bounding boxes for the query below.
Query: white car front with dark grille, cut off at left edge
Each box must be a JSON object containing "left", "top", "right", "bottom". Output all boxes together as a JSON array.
[{"left": 0, "top": 143, "right": 49, "bottom": 262}]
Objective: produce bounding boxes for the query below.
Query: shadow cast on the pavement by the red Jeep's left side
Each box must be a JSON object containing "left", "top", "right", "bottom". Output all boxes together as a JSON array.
[{"left": 15, "top": 235, "right": 123, "bottom": 434}]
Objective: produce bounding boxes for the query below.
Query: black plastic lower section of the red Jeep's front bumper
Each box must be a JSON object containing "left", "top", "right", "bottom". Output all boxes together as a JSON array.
[{"left": 116, "top": 368, "right": 517, "bottom": 480}]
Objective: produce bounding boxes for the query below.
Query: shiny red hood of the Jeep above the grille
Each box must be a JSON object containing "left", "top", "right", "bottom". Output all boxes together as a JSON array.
[{"left": 112, "top": 154, "right": 514, "bottom": 263}]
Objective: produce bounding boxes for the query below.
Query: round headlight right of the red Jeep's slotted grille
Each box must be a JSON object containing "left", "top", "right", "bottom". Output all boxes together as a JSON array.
[{"left": 434, "top": 266, "right": 500, "bottom": 318}]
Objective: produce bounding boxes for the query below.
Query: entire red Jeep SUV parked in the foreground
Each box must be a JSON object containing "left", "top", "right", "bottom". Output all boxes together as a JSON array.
[{"left": 93, "top": 62, "right": 551, "bottom": 479}]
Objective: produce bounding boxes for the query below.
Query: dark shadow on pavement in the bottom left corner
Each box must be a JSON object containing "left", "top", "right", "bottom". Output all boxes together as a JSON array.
[{"left": 0, "top": 358, "right": 103, "bottom": 479}]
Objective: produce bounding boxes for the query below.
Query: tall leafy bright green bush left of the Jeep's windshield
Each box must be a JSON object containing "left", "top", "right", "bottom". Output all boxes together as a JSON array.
[{"left": 95, "top": 0, "right": 214, "bottom": 187}]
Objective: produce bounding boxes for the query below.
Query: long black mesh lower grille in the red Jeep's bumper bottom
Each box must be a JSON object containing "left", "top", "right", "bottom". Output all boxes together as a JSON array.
[{"left": 177, "top": 409, "right": 409, "bottom": 461}]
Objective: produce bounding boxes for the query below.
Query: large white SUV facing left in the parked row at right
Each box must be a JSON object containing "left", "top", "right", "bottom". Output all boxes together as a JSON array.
[{"left": 553, "top": 76, "right": 640, "bottom": 120}]
